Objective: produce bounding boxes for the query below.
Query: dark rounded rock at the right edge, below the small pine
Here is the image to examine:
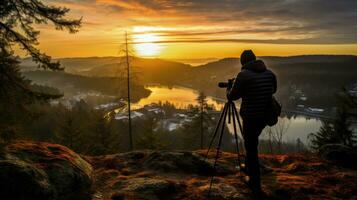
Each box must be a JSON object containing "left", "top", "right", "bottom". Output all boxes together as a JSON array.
[{"left": 319, "top": 144, "right": 357, "bottom": 167}]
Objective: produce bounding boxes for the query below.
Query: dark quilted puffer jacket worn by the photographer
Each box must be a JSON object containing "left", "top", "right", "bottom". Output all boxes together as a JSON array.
[{"left": 227, "top": 60, "right": 277, "bottom": 118}]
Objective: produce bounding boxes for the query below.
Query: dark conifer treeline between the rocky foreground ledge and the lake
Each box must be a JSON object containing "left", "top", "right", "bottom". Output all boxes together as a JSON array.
[{"left": 1, "top": 97, "right": 307, "bottom": 155}]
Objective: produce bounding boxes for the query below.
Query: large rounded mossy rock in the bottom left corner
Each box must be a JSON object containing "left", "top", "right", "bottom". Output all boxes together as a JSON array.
[{"left": 0, "top": 141, "right": 93, "bottom": 200}]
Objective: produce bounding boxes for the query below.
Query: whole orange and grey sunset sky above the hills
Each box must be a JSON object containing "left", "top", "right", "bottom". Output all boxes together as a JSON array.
[{"left": 27, "top": 0, "right": 357, "bottom": 59}]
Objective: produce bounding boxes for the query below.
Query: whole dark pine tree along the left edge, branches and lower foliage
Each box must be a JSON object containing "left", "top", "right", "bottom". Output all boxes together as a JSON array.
[{"left": 0, "top": 0, "right": 81, "bottom": 141}]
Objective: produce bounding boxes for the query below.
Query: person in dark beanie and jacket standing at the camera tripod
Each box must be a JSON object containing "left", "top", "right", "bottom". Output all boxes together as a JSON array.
[{"left": 227, "top": 50, "right": 277, "bottom": 193}]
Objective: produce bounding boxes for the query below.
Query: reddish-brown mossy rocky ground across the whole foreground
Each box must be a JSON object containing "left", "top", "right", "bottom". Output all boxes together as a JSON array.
[{"left": 0, "top": 141, "right": 357, "bottom": 200}]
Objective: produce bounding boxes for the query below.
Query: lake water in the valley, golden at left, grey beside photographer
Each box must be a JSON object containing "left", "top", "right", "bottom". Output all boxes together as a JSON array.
[{"left": 132, "top": 86, "right": 322, "bottom": 143}]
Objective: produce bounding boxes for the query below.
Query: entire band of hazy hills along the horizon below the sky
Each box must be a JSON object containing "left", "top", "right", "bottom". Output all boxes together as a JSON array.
[{"left": 22, "top": 55, "right": 357, "bottom": 108}]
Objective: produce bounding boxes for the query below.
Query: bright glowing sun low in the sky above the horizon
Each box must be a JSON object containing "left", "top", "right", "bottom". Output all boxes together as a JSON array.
[{"left": 133, "top": 33, "right": 163, "bottom": 57}]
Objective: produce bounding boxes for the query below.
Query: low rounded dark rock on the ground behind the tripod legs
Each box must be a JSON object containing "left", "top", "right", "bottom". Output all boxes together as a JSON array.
[{"left": 144, "top": 151, "right": 232, "bottom": 175}]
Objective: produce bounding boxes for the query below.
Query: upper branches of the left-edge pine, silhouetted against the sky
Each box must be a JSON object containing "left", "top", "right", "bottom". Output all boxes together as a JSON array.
[{"left": 0, "top": 0, "right": 81, "bottom": 70}]
